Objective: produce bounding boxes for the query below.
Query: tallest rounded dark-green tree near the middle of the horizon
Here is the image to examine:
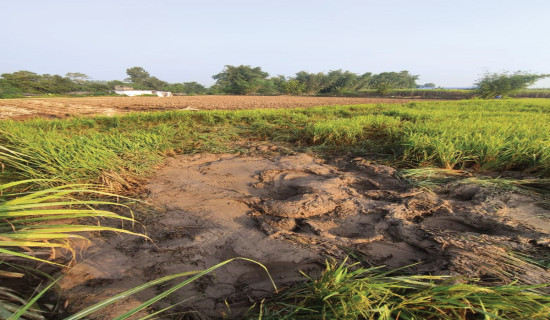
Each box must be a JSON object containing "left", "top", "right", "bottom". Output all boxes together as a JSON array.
[{"left": 212, "top": 65, "right": 269, "bottom": 95}]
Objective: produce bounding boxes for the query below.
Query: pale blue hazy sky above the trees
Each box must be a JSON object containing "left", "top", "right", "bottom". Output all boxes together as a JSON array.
[{"left": 0, "top": 0, "right": 550, "bottom": 88}]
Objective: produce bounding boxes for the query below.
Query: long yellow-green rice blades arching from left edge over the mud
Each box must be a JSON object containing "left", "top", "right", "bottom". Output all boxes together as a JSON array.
[{"left": 0, "top": 180, "right": 143, "bottom": 264}]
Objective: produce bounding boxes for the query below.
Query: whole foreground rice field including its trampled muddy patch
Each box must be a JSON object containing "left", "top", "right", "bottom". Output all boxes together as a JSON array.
[{"left": 0, "top": 100, "right": 550, "bottom": 319}]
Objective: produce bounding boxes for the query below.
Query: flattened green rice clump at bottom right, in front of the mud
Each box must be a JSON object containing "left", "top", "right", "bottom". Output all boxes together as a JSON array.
[{"left": 259, "top": 261, "right": 550, "bottom": 320}]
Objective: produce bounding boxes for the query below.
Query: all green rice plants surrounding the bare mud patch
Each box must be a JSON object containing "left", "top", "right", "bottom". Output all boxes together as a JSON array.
[{"left": 0, "top": 98, "right": 550, "bottom": 319}]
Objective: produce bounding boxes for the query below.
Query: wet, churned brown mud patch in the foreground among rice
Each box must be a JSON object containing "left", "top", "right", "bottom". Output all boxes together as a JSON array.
[{"left": 61, "top": 154, "right": 550, "bottom": 319}]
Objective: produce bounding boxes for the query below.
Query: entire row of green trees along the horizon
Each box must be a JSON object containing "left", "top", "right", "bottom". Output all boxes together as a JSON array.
[{"left": 0, "top": 65, "right": 549, "bottom": 98}]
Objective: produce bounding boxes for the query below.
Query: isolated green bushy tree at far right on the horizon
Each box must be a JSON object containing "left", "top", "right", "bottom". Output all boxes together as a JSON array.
[{"left": 475, "top": 71, "right": 550, "bottom": 98}]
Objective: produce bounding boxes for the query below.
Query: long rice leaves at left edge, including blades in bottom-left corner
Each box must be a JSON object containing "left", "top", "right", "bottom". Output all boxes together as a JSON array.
[{"left": 0, "top": 180, "right": 147, "bottom": 319}]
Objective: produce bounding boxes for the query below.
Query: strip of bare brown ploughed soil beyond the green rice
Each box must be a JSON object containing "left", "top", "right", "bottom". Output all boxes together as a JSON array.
[{"left": 0, "top": 96, "right": 436, "bottom": 120}]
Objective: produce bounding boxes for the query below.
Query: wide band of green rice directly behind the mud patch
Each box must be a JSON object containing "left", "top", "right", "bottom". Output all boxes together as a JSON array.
[{"left": 0, "top": 100, "right": 550, "bottom": 183}]
